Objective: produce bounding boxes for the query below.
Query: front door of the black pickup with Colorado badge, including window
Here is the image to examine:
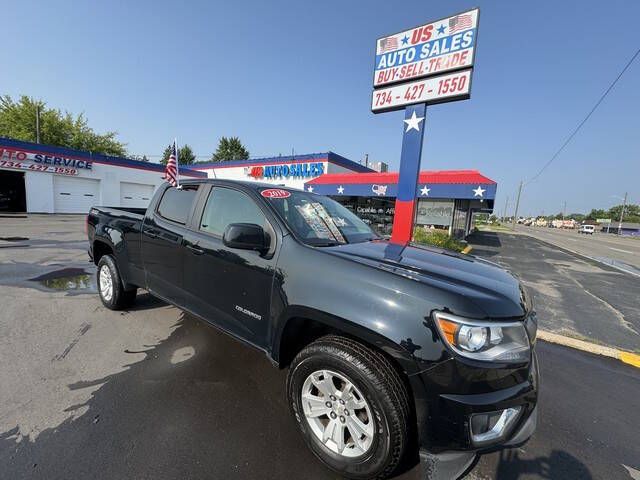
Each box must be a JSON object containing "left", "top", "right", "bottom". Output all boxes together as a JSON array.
[{"left": 185, "top": 186, "right": 276, "bottom": 347}]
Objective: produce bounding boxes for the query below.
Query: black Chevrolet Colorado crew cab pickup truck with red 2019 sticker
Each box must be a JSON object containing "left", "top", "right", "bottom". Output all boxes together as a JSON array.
[{"left": 87, "top": 180, "right": 538, "bottom": 479}]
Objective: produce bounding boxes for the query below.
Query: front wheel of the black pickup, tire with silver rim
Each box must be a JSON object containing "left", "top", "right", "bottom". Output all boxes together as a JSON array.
[{"left": 287, "top": 335, "right": 409, "bottom": 479}]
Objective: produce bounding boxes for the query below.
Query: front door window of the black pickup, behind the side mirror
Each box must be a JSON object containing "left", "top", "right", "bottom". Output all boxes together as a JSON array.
[{"left": 200, "top": 187, "right": 266, "bottom": 236}]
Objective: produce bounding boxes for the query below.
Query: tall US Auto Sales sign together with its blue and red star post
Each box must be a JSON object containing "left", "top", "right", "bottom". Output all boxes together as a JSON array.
[{"left": 371, "top": 9, "right": 480, "bottom": 245}]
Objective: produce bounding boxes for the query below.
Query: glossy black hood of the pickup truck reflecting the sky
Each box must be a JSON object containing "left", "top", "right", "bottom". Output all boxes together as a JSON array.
[{"left": 323, "top": 240, "right": 531, "bottom": 318}]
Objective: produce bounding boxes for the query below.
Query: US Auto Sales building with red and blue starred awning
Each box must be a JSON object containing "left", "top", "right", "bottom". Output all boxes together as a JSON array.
[{"left": 195, "top": 152, "right": 497, "bottom": 238}]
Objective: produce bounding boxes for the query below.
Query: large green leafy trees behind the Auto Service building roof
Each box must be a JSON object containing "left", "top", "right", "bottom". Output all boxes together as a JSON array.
[{"left": 0, "top": 95, "right": 127, "bottom": 157}]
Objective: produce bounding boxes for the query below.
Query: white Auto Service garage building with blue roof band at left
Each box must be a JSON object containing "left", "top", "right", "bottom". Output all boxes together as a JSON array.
[{"left": 0, "top": 138, "right": 207, "bottom": 213}]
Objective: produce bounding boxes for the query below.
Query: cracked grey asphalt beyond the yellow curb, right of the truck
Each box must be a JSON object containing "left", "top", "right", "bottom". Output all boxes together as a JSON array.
[{"left": 470, "top": 232, "right": 640, "bottom": 351}]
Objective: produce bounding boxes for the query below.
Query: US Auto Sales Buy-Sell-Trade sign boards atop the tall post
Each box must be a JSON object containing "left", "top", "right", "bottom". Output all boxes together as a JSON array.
[{"left": 371, "top": 8, "right": 480, "bottom": 113}]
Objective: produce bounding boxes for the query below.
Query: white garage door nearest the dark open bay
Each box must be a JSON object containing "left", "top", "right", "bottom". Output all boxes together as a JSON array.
[{"left": 53, "top": 175, "right": 100, "bottom": 213}]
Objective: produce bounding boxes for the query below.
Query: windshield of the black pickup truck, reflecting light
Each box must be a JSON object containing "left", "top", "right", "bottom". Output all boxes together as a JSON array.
[{"left": 262, "top": 190, "right": 378, "bottom": 246}]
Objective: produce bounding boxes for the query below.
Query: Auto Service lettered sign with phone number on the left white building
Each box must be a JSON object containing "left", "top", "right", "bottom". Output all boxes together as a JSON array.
[{"left": 0, "top": 148, "right": 93, "bottom": 175}]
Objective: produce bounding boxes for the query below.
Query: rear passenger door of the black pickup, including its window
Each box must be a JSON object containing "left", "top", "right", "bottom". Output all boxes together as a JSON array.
[{"left": 141, "top": 185, "right": 198, "bottom": 306}]
